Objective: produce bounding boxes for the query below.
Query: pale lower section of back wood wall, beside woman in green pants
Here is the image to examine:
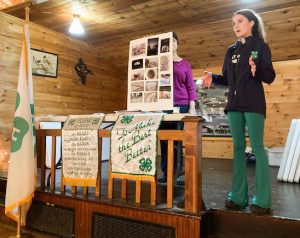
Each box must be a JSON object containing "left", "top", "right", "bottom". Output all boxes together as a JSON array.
[{"left": 193, "top": 59, "right": 300, "bottom": 158}]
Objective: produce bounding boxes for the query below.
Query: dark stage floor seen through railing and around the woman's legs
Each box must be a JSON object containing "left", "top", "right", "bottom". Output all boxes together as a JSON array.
[{"left": 33, "top": 159, "right": 300, "bottom": 219}]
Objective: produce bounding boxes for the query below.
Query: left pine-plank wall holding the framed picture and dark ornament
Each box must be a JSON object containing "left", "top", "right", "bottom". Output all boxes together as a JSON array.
[{"left": 0, "top": 12, "right": 127, "bottom": 172}]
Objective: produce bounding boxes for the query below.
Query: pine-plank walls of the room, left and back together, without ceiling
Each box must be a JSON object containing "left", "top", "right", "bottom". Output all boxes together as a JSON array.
[{"left": 0, "top": 3, "right": 300, "bottom": 165}]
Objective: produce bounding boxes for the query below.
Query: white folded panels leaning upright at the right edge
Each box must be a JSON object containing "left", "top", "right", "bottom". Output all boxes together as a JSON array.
[{"left": 277, "top": 119, "right": 300, "bottom": 183}]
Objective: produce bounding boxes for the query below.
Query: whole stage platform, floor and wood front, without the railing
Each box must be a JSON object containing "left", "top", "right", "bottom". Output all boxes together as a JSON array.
[{"left": 1, "top": 159, "right": 300, "bottom": 238}]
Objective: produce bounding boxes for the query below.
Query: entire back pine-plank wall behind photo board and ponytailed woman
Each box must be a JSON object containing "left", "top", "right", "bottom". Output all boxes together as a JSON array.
[{"left": 95, "top": 4, "right": 300, "bottom": 158}]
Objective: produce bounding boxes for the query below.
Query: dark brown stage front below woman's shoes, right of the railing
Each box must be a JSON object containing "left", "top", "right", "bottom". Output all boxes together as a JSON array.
[{"left": 201, "top": 210, "right": 300, "bottom": 238}]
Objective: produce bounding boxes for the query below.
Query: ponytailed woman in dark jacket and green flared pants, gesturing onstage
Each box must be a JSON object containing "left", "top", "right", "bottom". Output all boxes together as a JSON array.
[{"left": 202, "top": 9, "right": 275, "bottom": 215}]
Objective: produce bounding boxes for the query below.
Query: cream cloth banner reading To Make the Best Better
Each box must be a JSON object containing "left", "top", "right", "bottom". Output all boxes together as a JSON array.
[{"left": 111, "top": 114, "right": 162, "bottom": 176}]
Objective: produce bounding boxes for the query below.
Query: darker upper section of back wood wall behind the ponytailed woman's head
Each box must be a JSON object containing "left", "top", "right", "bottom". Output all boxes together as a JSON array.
[{"left": 99, "top": 4, "right": 300, "bottom": 69}]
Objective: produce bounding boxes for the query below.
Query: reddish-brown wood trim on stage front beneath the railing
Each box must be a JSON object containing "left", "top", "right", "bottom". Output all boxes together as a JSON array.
[{"left": 35, "top": 192, "right": 201, "bottom": 238}]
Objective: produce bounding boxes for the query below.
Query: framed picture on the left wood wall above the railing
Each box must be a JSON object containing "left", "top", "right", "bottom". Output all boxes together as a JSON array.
[{"left": 31, "top": 49, "right": 58, "bottom": 78}]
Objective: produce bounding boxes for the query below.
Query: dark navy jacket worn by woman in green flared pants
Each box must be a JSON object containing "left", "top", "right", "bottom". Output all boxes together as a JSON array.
[{"left": 213, "top": 36, "right": 275, "bottom": 116}]
